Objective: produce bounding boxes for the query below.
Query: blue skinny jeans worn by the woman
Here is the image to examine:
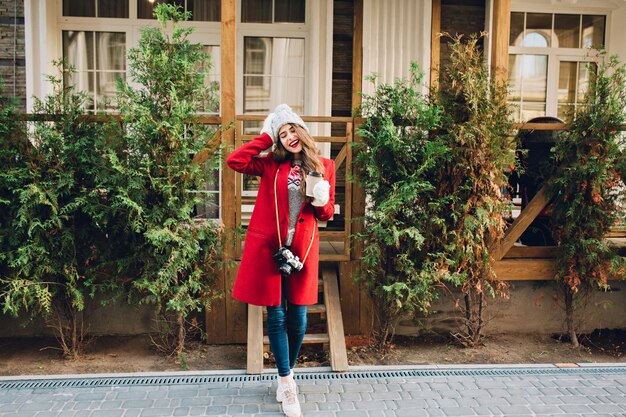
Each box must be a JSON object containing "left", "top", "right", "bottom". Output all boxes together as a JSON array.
[{"left": 267, "top": 277, "right": 307, "bottom": 376}]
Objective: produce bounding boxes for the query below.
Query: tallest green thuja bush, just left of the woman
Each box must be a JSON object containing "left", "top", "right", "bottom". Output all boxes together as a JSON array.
[{"left": 114, "top": 4, "right": 221, "bottom": 359}]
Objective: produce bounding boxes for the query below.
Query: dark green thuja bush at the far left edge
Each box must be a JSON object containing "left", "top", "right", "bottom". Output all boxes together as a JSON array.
[{"left": 0, "top": 62, "right": 117, "bottom": 356}]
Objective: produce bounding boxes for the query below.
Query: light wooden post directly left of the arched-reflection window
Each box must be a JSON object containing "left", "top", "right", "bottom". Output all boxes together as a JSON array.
[{"left": 491, "top": 0, "right": 511, "bottom": 82}]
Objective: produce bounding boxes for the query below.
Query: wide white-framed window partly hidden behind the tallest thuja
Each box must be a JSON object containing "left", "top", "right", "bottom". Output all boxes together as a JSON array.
[{"left": 56, "top": 0, "right": 221, "bottom": 219}]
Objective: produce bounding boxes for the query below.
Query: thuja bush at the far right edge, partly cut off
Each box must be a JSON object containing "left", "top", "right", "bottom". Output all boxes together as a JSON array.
[{"left": 548, "top": 55, "right": 626, "bottom": 347}]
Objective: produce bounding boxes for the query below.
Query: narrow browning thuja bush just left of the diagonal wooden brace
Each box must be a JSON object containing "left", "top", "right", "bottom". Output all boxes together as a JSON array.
[{"left": 433, "top": 35, "right": 516, "bottom": 345}]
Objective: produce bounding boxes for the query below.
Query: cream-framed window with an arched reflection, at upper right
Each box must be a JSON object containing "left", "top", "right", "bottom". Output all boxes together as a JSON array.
[{"left": 508, "top": 12, "right": 606, "bottom": 122}]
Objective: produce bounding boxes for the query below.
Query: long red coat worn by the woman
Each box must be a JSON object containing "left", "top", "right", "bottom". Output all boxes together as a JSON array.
[{"left": 226, "top": 134, "right": 335, "bottom": 306}]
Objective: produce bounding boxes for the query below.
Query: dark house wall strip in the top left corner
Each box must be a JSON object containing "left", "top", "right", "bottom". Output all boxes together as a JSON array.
[{"left": 0, "top": 0, "right": 26, "bottom": 107}]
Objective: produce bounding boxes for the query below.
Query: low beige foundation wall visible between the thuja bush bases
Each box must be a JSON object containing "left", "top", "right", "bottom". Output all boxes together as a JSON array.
[{"left": 0, "top": 281, "right": 626, "bottom": 337}]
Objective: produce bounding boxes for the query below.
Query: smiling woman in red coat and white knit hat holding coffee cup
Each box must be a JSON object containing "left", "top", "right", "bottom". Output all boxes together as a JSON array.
[{"left": 226, "top": 104, "right": 335, "bottom": 417}]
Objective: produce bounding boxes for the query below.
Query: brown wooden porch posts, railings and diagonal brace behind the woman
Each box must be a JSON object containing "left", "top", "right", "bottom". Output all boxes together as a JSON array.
[{"left": 206, "top": 0, "right": 626, "bottom": 343}]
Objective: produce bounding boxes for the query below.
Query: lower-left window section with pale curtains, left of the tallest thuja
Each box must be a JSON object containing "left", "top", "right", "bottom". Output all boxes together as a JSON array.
[{"left": 63, "top": 30, "right": 126, "bottom": 111}]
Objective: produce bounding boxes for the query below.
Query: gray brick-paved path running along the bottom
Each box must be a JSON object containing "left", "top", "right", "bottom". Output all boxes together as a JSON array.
[{"left": 0, "top": 364, "right": 626, "bottom": 417}]
